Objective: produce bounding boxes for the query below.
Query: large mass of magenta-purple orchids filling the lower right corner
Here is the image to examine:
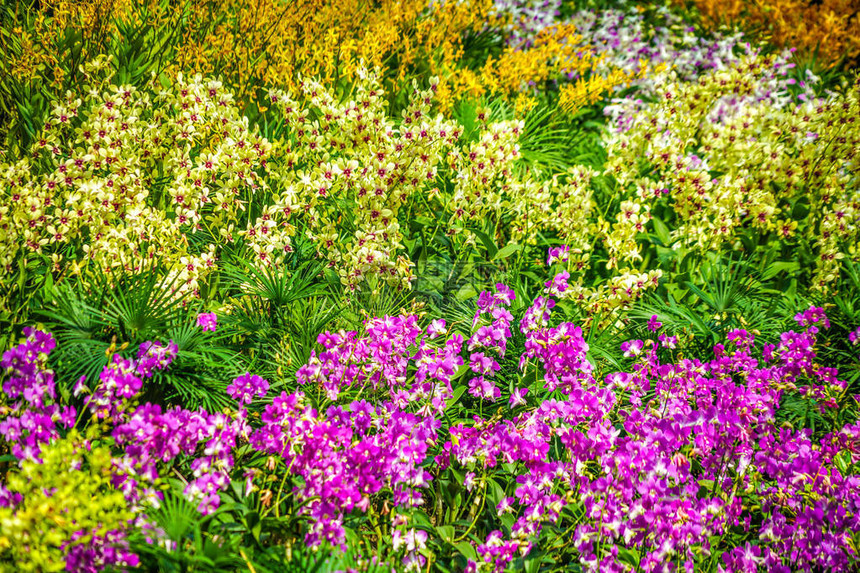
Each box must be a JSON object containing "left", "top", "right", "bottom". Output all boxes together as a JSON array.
[{"left": 454, "top": 301, "right": 860, "bottom": 571}]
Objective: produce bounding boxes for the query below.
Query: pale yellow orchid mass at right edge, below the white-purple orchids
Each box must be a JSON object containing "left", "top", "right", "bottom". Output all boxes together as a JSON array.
[{"left": 606, "top": 53, "right": 860, "bottom": 289}]
